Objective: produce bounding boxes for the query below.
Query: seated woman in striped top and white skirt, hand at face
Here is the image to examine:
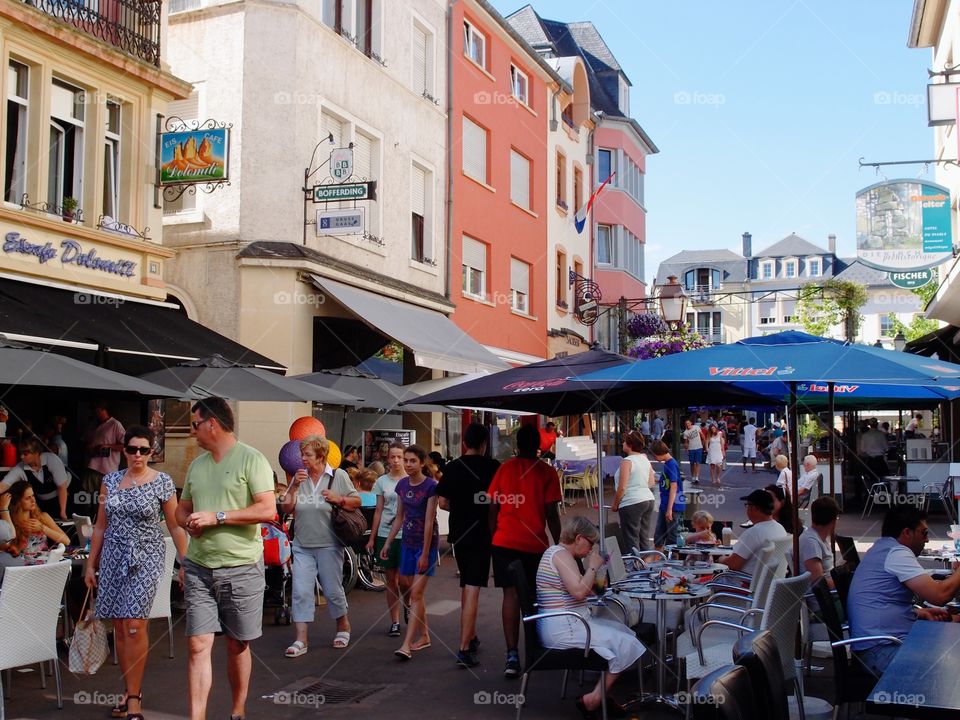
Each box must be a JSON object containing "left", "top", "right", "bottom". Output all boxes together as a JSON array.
[{"left": 537, "top": 515, "right": 644, "bottom": 717}]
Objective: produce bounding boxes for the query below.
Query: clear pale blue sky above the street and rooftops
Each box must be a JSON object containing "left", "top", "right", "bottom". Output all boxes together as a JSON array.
[{"left": 493, "top": 0, "right": 933, "bottom": 281}]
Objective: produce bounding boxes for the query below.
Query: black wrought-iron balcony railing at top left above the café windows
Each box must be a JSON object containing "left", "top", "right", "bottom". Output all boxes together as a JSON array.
[{"left": 23, "top": 0, "right": 161, "bottom": 67}]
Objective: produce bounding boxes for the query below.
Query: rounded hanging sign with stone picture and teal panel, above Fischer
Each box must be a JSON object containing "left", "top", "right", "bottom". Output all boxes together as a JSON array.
[{"left": 857, "top": 180, "right": 953, "bottom": 271}]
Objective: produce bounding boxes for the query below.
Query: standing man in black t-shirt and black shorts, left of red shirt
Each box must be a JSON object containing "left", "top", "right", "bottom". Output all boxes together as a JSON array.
[{"left": 437, "top": 423, "right": 500, "bottom": 668}]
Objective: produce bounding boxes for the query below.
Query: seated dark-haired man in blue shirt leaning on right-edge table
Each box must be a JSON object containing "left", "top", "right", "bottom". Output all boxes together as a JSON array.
[{"left": 847, "top": 505, "right": 960, "bottom": 677}]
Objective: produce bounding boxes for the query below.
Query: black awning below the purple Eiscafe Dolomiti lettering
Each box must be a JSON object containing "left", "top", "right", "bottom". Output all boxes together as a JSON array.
[{"left": 0, "top": 278, "right": 283, "bottom": 375}]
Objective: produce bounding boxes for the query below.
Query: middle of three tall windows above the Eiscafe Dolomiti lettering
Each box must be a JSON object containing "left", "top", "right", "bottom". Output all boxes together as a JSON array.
[{"left": 47, "top": 78, "right": 86, "bottom": 214}]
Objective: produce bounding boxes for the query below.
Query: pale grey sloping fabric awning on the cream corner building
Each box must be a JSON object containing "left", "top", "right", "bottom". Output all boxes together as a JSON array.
[{"left": 310, "top": 275, "right": 510, "bottom": 374}]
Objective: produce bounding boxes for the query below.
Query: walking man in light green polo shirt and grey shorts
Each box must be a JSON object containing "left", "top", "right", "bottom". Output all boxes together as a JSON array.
[{"left": 177, "top": 398, "right": 277, "bottom": 720}]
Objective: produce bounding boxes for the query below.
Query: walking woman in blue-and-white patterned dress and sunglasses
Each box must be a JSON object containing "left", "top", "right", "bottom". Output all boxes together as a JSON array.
[{"left": 84, "top": 426, "right": 187, "bottom": 720}]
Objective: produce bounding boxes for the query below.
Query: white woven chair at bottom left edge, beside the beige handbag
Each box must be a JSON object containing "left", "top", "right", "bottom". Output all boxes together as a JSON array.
[{"left": 0, "top": 562, "right": 70, "bottom": 720}]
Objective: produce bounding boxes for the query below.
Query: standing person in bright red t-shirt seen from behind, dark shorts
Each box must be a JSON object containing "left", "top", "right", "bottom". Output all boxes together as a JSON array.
[{"left": 487, "top": 425, "right": 561, "bottom": 678}]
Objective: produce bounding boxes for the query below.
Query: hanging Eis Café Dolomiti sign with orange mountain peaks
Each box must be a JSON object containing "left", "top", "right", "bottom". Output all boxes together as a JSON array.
[{"left": 160, "top": 127, "right": 230, "bottom": 186}]
